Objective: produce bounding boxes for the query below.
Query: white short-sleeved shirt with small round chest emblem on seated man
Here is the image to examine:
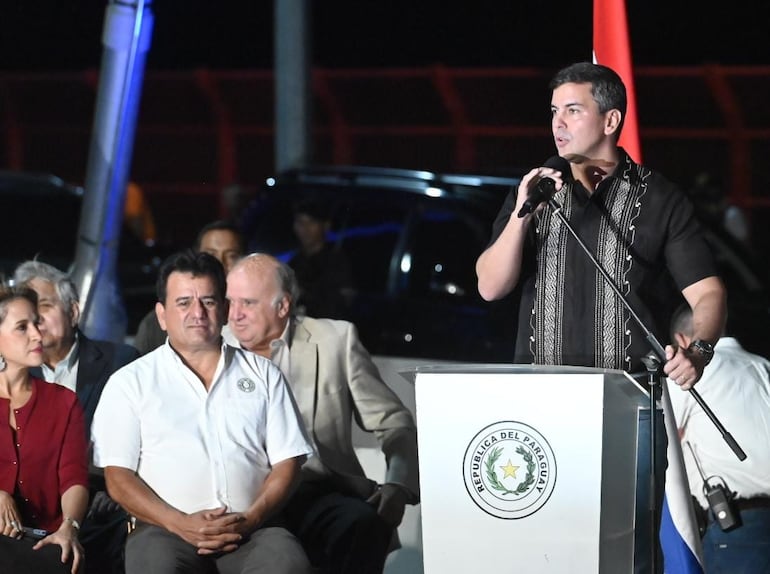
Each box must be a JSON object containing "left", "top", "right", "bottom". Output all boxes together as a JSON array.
[{"left": 92, "top": 342, "right": 312, "bottom": 513}]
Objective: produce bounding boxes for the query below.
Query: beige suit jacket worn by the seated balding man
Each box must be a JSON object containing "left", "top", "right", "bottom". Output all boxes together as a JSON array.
[{"left": 287, "top": 317, "right": 419, "bottom": 504}]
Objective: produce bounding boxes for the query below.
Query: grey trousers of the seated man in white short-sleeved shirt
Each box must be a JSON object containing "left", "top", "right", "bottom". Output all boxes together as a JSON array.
[{"left": 126, "top": 524, "right": 312, "bottom": 574}]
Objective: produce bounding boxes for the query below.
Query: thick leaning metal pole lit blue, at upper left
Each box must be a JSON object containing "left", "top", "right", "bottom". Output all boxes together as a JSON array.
[{"left": 72, "top": 0, "right": 153, "bottom": 341}]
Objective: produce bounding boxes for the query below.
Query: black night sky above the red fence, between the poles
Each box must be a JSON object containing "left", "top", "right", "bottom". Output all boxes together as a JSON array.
[{"left": 0, "top": 0, "right": 770, "bottom": 70}]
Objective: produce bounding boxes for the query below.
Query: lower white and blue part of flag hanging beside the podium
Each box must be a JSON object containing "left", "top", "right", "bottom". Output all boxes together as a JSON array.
[{"left": 660, "top": 383, "right": 703, "bottom": 574}]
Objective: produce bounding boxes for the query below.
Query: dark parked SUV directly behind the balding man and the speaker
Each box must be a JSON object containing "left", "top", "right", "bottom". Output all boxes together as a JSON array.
[{"left": 247, "top": 167, "right": 770, "bottom": 362}]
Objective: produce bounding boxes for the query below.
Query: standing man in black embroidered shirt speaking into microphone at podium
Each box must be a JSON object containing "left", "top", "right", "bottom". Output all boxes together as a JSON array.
[{"left": 476, "top": 63, "right": 726, "bottom": 571}]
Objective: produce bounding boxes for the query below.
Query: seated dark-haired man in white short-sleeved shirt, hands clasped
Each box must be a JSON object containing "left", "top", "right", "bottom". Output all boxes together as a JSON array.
[{"left": 93, "top": 250, "right": 312, "bottom": 574}]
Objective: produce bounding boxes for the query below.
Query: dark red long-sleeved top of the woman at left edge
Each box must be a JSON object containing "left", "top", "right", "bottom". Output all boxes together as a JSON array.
[{"left": 0, "top": 377, "right": 88, "bottom": 531}]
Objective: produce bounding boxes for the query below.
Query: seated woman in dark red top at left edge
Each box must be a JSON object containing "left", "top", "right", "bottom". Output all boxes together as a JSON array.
[{"left": 0, "top": 287, "right": 88, "bottom": 574}]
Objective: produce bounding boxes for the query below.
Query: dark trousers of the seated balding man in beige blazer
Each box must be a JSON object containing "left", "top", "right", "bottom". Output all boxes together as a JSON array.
[{"left": 283, "top": 482, "right": 393, "bottom": 574}]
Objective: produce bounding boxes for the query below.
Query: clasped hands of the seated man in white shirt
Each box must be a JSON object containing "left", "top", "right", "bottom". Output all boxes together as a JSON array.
[{"left": 174, "top": 507, "right": 257, "bottom": 554}]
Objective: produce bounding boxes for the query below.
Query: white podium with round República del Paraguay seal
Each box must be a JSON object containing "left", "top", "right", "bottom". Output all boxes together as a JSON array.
[{"left": 414, "top": 365, "right": 649, "bottom": 574}]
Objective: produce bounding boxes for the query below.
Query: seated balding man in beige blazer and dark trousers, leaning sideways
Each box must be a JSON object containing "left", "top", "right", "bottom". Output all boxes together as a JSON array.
[{"left": 223, "top": 254, "right": 419, "bottom": 574}]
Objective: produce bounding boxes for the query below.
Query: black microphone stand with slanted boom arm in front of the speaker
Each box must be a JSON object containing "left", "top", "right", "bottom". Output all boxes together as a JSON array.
[{"left": 540, "top": 193, "right": 746, "bottom": 574}]
